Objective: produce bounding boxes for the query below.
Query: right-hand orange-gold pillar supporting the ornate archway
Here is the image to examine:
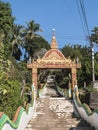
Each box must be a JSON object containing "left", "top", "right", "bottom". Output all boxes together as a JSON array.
[{"left": 71, "top": 67, "right": 77, "bottom": 90}]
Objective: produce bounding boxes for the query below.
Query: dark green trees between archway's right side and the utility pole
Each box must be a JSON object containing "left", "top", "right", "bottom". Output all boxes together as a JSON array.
[{"left": 62, "top": 44, "right": 95, "bottom": 87}]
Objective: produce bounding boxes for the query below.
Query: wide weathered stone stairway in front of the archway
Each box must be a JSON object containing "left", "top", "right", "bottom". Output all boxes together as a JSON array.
[{"left": 25, "top": 88, "right": 94, "bottom": 130}]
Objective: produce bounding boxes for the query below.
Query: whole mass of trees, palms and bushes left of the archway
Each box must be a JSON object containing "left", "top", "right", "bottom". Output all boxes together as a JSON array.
[{"left": 0, "top": 1, "right": 50, "bottom": 118}]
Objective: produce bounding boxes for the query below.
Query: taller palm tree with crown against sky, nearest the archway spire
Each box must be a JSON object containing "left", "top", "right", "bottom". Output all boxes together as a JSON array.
[{"left": 23, "top": 20, "right": 42, "bottom": 59}]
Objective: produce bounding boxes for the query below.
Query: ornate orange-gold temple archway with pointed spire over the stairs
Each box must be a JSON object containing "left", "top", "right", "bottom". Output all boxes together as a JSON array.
[{"left": 27, "top": 34, "right": 81, "bottom": 89}]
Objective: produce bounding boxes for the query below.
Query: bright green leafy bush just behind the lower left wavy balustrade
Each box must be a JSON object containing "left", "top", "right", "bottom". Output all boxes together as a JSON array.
[{"left": 0, "top": 80, "right": 23, "bottom": 119}]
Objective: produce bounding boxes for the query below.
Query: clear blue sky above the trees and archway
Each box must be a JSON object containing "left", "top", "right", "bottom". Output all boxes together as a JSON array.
[{"left": 2, "top": 0, "right": 98, "bottom": 48}]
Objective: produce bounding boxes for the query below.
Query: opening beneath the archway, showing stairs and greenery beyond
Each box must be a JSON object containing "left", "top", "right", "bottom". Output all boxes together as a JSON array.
[{"left": 37, "top": 69, "right": 71, "bottom": 97}]
